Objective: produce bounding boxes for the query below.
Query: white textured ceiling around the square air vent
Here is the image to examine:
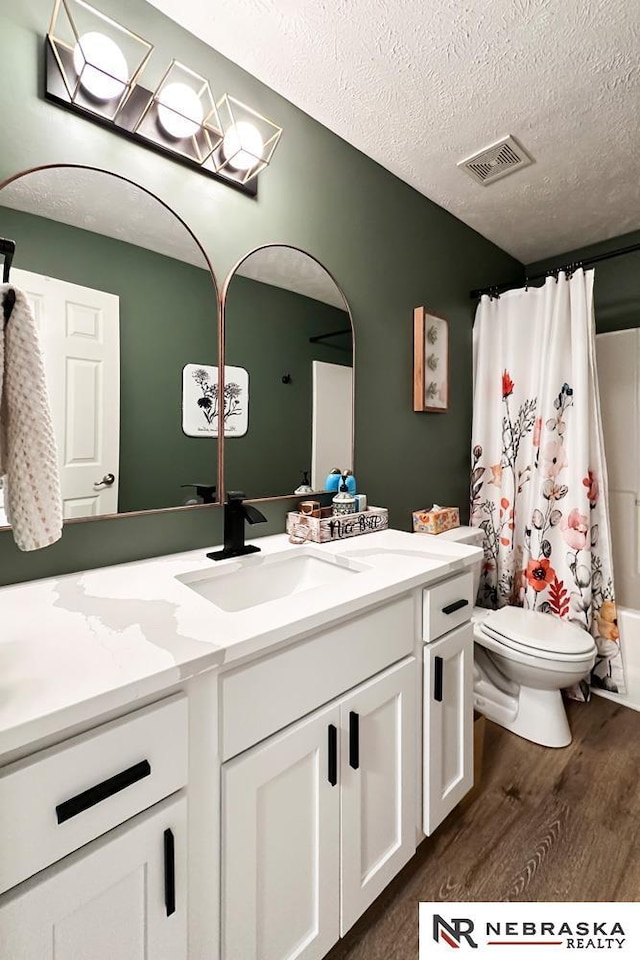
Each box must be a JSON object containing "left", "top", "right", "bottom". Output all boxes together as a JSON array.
[{"left": 146, "top": 0, "right": 640, "bottom": 262}]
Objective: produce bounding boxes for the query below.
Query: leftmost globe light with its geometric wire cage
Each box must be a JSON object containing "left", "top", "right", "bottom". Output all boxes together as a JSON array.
[{"left": 47, "top": 0, "right": 153, "bottom": 121}]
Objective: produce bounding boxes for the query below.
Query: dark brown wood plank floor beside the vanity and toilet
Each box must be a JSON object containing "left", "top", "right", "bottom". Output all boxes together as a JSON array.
[{"left": 329, "top": 697, "right": 640, "bottom": 960}]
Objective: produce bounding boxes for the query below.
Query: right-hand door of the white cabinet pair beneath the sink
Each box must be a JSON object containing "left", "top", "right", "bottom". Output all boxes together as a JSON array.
[{"left": 340, "top": 657, "right": 418, "bottom": 936}]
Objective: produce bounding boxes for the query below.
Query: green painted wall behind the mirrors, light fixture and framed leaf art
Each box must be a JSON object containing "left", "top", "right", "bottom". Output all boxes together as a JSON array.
[{"left": 0, "top": 0, "right": 523, "bottom": 582}]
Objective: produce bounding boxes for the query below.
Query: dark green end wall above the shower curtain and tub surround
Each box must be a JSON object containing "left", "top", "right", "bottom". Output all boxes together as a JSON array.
[{"left": 527, "top": 230, "right": 640, "bottom": 333}]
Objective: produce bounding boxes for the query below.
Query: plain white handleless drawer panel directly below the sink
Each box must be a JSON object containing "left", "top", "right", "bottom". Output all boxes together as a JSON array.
[{"left": 221, "top": 596, "right": 415, "bottom": 761}]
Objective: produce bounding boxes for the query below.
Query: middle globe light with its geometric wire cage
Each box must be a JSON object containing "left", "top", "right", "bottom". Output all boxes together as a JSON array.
[{"left": 133, "top": 60, "right": 222, "bottom": 164}]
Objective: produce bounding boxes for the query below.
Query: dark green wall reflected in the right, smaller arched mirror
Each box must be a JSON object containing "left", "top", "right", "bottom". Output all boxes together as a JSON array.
[{"left": 225, "top": 276, "right": 351, "bottom": 497}]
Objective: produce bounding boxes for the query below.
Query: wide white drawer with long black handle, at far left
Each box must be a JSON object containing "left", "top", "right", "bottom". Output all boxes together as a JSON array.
[{"left": 0, "top": 694, "right": 188, "bottom": 893}]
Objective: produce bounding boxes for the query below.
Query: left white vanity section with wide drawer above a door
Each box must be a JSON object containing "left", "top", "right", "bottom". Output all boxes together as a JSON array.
[{"left": 0, "top": 694, "right": 188, "bottom": 960}]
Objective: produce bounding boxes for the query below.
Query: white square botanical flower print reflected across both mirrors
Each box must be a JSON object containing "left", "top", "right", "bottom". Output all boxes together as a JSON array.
[{"left": 182, "top": 363, "right": 249, "bottom": 437}]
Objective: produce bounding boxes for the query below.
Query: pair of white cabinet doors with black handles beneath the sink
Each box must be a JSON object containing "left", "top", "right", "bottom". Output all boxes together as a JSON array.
[{"left": 222, "top": 632, "right": 417, "bottom": 960}]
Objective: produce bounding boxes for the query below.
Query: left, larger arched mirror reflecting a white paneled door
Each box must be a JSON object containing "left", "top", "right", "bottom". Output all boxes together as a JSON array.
[{"left": 0, "top": 165, "right": 219, "bottom": 526}]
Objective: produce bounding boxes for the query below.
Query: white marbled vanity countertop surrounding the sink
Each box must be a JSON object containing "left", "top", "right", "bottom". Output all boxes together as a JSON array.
[{"left": 0, "top": 530, "right": 479, "bottom": 757}]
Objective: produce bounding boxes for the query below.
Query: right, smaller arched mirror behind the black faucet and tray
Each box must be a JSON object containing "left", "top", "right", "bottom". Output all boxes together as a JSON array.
[{"left": 223, "top": 244, "right": 354, "bottom": 499}]
